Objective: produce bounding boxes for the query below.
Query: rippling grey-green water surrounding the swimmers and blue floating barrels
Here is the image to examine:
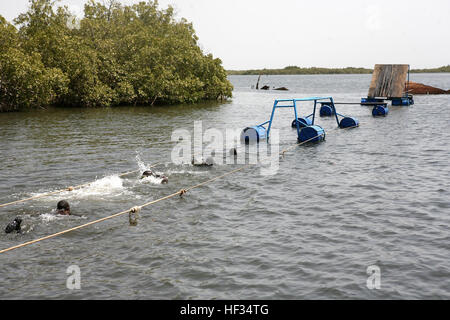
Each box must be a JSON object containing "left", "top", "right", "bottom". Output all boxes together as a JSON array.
[{"left": 0, "top": 74, "right": 450, "bottom": 299}]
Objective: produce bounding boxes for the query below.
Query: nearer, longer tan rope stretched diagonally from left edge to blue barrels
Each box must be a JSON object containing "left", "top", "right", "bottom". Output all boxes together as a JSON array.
[{"left": 0, "top": 133, "right": 323, "bottom": 254}]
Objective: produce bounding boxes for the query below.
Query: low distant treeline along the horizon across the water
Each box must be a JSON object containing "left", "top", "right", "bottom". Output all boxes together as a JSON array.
[{"left": 227, "top": 65, "right": 450, "bottom": 75}]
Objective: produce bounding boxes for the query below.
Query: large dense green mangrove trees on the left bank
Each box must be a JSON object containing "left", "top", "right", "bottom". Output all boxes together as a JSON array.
[{"left": 0, "top": 0, "right": 233, "bottom": 111}]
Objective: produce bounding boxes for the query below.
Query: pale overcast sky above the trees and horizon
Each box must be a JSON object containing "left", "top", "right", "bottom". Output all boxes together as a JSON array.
[{"left": 0, "top": 0, "right": 450, "bottom": 69}]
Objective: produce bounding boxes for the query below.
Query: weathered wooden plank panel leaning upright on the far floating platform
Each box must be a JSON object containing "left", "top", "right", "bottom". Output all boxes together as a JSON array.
[{"left": 367, "top": 64, "right": 409, "bottom": 98}]
